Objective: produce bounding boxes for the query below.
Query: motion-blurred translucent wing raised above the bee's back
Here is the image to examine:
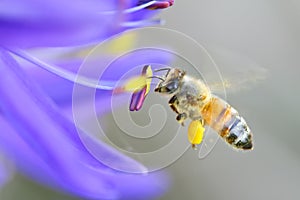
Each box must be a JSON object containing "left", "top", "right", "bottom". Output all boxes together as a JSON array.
[{"left": 203, "top": 48, "right": 267, "bottom": 94}]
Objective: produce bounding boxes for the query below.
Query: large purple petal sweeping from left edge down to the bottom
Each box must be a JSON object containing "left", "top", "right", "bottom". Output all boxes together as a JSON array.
[{"left": 0, "top": 49, "right": 169, "bottom": 198}]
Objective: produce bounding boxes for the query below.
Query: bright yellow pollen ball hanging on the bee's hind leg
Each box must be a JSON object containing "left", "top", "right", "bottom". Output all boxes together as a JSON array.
[{"left": 188, "top": 120, "right": 205, "bottom": 145}]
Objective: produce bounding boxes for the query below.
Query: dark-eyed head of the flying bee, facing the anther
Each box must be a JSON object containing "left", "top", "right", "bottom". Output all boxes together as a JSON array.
[{"left": 154, "top": 68, "right": 185, "bottom": 94}]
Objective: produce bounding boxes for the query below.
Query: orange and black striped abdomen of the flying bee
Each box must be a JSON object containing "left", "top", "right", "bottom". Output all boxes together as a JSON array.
[{"left": 202, "top": 97, "right": 253, "bottom": 150}]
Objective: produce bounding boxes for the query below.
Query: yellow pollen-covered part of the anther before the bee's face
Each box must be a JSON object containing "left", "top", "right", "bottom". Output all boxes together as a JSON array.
[{"left": 123, "top": 66, "right": 153, "bottom": 94}]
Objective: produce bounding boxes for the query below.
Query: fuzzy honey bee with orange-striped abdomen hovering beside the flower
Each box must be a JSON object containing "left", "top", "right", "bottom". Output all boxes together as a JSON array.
[{"left": 154, "top": 68, "right": 253, "bottom": 150}]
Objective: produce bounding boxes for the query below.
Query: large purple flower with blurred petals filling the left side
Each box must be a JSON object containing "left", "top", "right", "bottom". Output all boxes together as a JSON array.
[{"left": 0, "top": 0, "right": 173, "bottom": 199}]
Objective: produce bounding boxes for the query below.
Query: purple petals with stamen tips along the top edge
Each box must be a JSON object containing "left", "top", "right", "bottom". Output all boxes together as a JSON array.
[{"left": 0, "top": 0, "right": 173, "bottom": 48}]
